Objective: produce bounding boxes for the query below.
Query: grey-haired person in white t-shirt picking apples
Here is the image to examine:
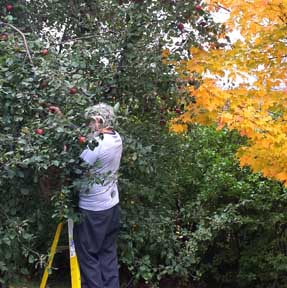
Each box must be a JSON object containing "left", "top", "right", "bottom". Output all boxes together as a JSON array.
[{"left": 74, "top": 103, "right": 122, "bottom": 288}]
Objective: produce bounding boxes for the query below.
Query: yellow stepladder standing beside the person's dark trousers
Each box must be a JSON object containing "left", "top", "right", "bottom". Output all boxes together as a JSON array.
[{"left": 40, "top": 219, "right": 81, "bottom": 288}]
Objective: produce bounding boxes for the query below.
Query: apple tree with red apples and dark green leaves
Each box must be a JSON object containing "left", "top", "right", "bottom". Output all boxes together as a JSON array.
[{"left": 0, "top": 0, "right": 226, "bottom": 281}]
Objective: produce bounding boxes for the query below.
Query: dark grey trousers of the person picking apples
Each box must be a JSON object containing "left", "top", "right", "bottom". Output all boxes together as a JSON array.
[{"left": 74, "top": 205, "right": 120, "bottom": 288}]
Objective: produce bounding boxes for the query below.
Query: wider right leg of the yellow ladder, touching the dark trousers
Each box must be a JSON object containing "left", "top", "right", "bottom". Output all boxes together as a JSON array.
[{"left": 68, "top": 219, "right": 81, "bottom": 288}]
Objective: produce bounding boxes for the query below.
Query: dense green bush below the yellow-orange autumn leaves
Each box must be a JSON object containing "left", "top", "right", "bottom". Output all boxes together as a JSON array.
[{"left": 120, "top": 127, "right": 287, "bottom": 287}]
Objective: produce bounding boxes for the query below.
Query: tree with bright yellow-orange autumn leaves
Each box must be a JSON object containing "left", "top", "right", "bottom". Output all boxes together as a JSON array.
[{"left": 173, "top": 0, "right": 287, "bottom": 183}]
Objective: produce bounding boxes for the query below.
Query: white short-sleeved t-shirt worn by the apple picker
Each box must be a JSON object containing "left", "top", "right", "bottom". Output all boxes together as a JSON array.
[{"left": 79, "top": 131, "right": 123, "bottom": 211}]
